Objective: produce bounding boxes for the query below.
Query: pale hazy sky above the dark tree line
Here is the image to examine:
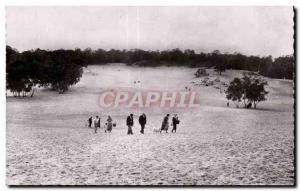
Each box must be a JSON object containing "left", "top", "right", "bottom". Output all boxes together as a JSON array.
[{"left": 6, "top": 7, "right": 293, "bottom": 57}]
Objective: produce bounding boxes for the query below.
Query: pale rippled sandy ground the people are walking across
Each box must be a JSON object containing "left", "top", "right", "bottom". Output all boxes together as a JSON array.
[{"left": 7, "top": 65, "right": 294, "bottom": 185}]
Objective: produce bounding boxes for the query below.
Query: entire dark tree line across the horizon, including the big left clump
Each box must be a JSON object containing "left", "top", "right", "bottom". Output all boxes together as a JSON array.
[{"left": 6, "top": 46, "right": 294, "bottom": 96}]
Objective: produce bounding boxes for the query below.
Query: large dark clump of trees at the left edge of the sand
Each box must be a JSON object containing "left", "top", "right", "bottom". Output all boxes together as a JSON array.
[{"left": 6, "top": 46, "right": 87, "bottom": 96}]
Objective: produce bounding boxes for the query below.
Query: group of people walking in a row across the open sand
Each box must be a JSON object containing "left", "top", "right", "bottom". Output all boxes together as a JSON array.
[{"left": 88, "top": 113, "right": 180, "bottom": 135}]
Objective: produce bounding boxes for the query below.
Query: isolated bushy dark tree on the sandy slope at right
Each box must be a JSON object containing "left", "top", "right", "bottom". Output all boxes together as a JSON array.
[{"left": 226, "top": 72, "right": 268, "bottom": 108}]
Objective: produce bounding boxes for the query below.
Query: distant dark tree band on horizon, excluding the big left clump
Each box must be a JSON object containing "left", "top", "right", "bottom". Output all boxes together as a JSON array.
[{"left": 79, "top": 48, "right": 294, "bottom": 79}]
